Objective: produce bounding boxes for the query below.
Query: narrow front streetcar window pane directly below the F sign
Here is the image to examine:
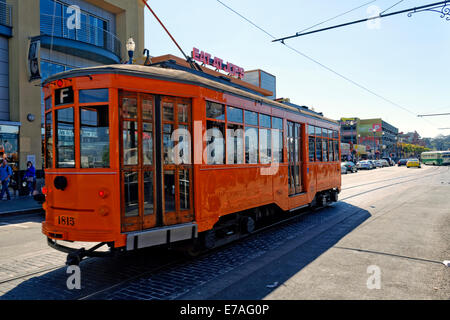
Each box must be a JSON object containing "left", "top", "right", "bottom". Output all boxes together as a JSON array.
[{"left": 55, "top": 108, "right": 75, "bottom": 168}]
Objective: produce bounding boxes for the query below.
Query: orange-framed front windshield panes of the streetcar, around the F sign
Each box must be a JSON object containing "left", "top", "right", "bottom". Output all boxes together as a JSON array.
[{"left": 45, "top": 87, "right": 110, "bottom": 169}]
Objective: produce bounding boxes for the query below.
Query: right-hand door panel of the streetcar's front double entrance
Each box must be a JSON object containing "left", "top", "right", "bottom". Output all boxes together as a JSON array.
[{"left": 159, "top": 96, "right": 194, "bottom": 225}]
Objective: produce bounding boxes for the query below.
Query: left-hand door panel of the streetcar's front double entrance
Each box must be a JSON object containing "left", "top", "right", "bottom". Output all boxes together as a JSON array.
[{"left": 119, "top": 92, "right": 158, "bottom": 232}]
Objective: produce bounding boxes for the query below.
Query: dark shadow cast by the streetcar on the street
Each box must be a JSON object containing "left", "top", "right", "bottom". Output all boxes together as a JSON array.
[{"left": 0, "top": 202, "right": 370, "bottom": 300}]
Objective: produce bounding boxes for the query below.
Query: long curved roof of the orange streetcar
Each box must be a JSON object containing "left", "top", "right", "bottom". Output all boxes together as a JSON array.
[{"left": 43, "top": 64, "right": 338, "bottom": 125}]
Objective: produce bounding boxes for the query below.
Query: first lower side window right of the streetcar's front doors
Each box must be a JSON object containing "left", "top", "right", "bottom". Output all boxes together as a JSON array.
[{"left": 206, "top": 121, "right": 225, "bottom": 164}]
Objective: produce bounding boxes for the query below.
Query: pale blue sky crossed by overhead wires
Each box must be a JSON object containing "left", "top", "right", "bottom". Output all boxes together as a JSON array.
[{"left": 145, "top": 0, "right": 450, "bottom": 137}]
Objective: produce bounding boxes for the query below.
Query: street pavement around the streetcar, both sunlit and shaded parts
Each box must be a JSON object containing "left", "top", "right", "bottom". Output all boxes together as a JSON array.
[{"left": 0, "top": 166, "right": 450, "bottom": 300}]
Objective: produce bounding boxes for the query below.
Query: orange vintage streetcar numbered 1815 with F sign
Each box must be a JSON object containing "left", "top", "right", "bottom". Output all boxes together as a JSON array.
[{"left": 42, "top": 63, "right": 341, "bottom": 264}]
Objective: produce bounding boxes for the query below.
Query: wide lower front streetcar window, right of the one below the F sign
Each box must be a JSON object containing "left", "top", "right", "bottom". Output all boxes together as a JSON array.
[{"left": 80, "top": 106, "right": 109, "bottom": 168}]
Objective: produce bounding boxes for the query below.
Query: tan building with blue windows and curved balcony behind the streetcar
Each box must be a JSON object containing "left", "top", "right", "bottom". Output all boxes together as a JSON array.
[{"left": 0, "top": 0, "right": 144, "bottom": 178}]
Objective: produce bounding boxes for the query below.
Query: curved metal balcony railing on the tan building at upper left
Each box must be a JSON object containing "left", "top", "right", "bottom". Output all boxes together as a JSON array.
[{"left": 40, "top": 14, "right": 121, "bottom": 57}]
